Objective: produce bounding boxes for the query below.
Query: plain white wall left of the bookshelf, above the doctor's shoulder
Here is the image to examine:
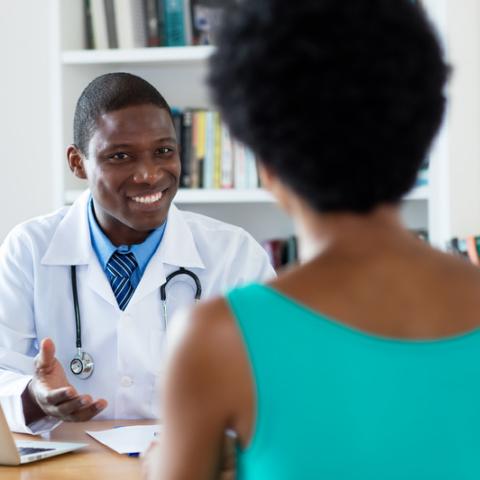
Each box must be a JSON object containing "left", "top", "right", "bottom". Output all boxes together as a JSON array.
[{"left": 0, "top": 0, "right": 54, "bottom": 241}]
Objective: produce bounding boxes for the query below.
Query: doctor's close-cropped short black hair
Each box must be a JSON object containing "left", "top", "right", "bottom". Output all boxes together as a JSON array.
[{"left": 73, "top": 72, "right": 173, "bottom": 155}]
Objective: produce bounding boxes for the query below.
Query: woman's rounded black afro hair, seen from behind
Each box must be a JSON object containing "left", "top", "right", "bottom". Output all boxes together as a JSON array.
[{"left": 208, "top": 0, "right": 449, "bottom": 212}]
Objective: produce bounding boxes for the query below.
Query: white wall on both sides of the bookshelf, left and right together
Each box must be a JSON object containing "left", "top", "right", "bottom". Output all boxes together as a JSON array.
[{"left": 0, "top": 0, "right": 480, "bottom": 241}]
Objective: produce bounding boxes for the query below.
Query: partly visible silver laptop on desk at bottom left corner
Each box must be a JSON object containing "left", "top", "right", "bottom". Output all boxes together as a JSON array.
[{"left": 0, "top": 405, "right": 87, "bottom": 465}]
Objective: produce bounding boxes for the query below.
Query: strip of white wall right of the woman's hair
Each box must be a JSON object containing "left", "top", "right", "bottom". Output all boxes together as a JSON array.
[{"left": 447, "top": 0, "right": 480, "bottom": 237}]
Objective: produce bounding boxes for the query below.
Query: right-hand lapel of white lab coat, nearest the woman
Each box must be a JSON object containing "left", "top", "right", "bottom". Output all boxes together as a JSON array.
[{"left": 127, "top": 204, "right": 205, "bottom": 309}]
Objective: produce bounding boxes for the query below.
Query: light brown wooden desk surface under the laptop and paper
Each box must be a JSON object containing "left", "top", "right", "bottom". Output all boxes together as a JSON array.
[{"left": 0, "top": 420, "right": 154, "bottom": 480}]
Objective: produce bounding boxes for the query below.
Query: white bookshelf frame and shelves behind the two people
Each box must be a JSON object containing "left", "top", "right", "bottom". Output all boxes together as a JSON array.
[{"left": 49, "top": 0, "right": 438, "bottom": 246}]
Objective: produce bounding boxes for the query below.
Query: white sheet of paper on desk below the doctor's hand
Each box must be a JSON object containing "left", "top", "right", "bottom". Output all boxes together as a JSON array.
[{"left": 85, "top": 425, "right": 161, "bottom": 454}]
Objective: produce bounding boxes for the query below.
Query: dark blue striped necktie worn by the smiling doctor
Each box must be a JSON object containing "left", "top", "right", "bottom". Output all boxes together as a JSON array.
[{"left": 107, "top": 252, "right": 138, "bottom": 310}]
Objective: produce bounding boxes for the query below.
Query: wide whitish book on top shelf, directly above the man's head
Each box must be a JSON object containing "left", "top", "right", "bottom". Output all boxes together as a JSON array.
[{"left": 114, "top": 0, "right": 147, "bottom": 49}]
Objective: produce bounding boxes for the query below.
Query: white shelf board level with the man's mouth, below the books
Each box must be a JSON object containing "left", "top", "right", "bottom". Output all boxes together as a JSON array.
[{"left": 64, "top": 188, "right": 274, "bottom": 204}]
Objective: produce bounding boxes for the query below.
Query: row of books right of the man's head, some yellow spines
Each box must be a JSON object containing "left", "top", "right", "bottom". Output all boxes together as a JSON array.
[{"left": 172, "top": 108, "right": 259, "bottom": 189}]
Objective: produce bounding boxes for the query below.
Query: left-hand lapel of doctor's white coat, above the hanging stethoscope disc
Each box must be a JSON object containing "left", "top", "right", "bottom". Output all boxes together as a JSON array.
[{"left": 42, "top": 190, "right": 117, "bottom": 305}]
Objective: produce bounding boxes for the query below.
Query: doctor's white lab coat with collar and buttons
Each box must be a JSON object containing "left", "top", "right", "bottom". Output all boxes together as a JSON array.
[{"left": 0, "top": 192, "right": 274, "bottom": 432}]
